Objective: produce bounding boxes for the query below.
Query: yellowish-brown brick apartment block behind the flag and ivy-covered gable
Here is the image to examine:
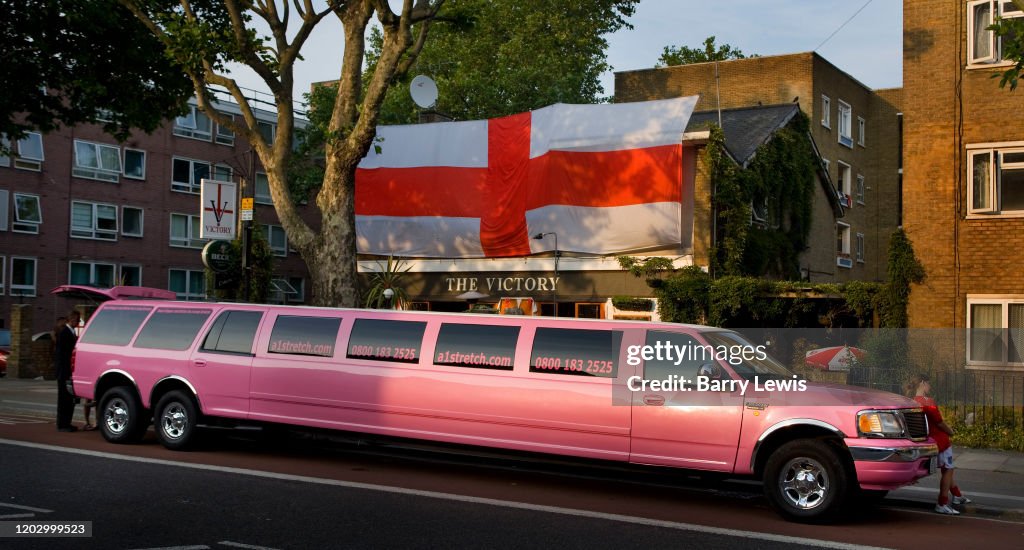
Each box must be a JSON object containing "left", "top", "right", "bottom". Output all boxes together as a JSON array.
[{"left": 615, "top": 52, "right": 900, "bottom": 282}]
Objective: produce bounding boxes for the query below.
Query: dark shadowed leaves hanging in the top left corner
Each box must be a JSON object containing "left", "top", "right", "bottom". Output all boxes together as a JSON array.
[{"left": 0, "top": 0, "right": 191, "bottom": 139}]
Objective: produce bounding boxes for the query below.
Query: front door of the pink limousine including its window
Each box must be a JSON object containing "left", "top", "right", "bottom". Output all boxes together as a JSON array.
[{"left": 630, "top": 331, "right": 742, "bottom": 471}]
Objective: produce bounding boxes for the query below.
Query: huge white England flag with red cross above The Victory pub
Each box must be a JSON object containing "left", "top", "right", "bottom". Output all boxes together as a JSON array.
[{"left": 355, "top": 97, "right": 697, "bottom": 258}]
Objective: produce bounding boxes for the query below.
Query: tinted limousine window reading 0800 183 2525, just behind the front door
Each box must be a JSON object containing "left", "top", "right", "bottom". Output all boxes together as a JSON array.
[{"left": 529, "top": 328, "right": 623, "bottom": 378}]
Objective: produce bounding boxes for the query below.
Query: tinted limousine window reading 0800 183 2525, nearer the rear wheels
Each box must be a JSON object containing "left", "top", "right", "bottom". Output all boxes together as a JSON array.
[{"left": 348, "top": 319, "right": 427, "bottom": 363}]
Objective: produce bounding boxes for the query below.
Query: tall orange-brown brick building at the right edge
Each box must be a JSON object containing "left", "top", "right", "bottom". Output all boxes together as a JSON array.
[{"left": 902, "top": 0, "right": 1024, "bottom": 370}]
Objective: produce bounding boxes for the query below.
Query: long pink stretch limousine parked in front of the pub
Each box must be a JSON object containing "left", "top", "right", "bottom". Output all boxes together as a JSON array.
[{"left": 72, "top": 288, "right": 936, "bottom": 520}]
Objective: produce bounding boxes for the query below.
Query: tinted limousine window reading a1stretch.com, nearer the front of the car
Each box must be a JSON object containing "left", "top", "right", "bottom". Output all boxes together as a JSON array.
[{"left": 434, "top": 323, "right": 519, "bottom": 371}]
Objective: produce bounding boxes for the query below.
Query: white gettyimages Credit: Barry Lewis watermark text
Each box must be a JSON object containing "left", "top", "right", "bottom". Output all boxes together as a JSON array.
[{"left": 626, "top": 342, "right": 807, "bottom": 395}]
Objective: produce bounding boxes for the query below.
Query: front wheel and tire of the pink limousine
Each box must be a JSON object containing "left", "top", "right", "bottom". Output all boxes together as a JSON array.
[{"left": 764, "top": 439, "right": 851, "bottom": 523}]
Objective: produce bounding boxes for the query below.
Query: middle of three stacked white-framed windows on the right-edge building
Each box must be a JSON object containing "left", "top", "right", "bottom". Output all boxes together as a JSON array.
[{"left": 968, "top": 147, "right": 1024, "bottom": 214}]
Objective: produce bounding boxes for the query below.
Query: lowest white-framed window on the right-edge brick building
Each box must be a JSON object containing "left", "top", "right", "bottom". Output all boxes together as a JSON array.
[{"left": 967, "top": 295, "right": 1024, "bottom": 367}]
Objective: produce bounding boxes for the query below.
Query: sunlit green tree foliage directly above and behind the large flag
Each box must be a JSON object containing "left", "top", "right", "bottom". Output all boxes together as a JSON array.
[{"left": 367, "top": 0, "right": 638, "bottom": 124}]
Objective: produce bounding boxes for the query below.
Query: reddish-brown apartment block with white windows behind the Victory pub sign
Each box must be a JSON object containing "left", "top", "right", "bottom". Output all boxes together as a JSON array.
[{"left": 0, "top": 96, "right": 306, "bottom": 340}]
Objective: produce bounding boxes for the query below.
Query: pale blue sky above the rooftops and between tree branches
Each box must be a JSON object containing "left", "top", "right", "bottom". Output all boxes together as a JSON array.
[{"left": 233, "top": 0, "right": 903, "bottom": 103}]
